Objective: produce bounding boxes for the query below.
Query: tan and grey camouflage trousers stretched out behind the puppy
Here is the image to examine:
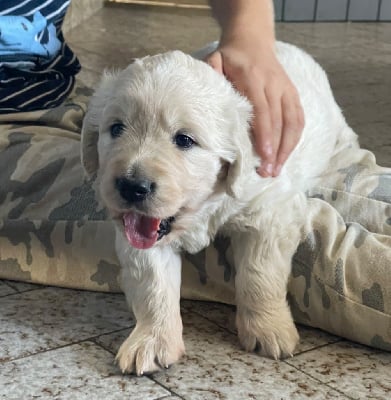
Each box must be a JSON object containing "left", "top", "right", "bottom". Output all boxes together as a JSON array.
[{"left": 0, "top": 82, "right": 391, "bottom": 350}]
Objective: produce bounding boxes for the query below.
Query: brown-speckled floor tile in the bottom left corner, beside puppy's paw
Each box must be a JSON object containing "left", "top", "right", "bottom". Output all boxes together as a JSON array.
[{"left": 0, "top": 342, "right": 170, "bottom": 400}]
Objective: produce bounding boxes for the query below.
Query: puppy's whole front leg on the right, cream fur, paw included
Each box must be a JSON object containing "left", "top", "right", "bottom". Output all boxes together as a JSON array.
[{"left": 232, "top": 200, "right": 300, "bottom": 359}]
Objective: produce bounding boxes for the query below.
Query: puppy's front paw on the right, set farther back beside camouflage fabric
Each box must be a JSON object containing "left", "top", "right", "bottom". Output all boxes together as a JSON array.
[{"left": 236, "top": 306, "right": 299, "bottom": 359}]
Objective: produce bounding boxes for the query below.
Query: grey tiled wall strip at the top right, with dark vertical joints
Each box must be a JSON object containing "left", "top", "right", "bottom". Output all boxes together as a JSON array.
[{"left": 273, "top": 0, "right": 391, "bottom": 21}]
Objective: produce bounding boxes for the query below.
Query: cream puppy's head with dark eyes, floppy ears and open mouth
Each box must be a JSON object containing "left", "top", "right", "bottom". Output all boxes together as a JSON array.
[{"left": 82, "top": 51, "right": 253, "bottom": 248}]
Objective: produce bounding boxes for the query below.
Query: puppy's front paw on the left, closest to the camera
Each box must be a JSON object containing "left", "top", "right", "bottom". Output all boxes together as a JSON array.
[{"left": 116, "top": 326, "right": 185, "bottom": 376}]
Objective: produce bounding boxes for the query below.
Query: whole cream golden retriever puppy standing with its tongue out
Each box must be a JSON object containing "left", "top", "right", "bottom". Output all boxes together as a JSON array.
[{"left": 82, "top": 43, "right": 357, "bottom": 375}]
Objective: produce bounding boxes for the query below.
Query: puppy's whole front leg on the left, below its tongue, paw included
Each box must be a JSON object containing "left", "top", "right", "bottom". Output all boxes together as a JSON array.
[{"left": 116, "top": 239, "right": 185, "bottom": 375}]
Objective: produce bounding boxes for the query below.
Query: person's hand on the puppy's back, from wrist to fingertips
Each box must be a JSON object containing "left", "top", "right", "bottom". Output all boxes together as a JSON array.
[{"left": 206, "top": 38, "right": 304, "bottom": 177}]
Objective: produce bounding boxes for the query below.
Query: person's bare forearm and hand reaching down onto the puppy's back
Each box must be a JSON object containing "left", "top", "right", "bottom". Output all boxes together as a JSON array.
[{"left": 207, "top": 0, "right": 304, "bottom": 177}]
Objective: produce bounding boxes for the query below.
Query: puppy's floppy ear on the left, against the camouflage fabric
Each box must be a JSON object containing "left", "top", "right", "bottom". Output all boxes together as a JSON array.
[{"left": 81, "top": 72, "right": 118, "bottom": 177}]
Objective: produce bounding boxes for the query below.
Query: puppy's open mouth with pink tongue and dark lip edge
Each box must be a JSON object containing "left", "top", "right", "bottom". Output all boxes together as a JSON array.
[{"left": 122, "top": 211, "right": 175, "bottom": 249}]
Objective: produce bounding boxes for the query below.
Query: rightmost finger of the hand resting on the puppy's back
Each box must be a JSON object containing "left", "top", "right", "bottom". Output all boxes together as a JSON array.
[{"left": 273, "top": 96, "right": 304, "bottom": 176}]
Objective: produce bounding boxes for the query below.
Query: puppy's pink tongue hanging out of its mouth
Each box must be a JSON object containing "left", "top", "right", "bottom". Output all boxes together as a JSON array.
[{"left": 123, "top": 212, "right": 160, "bottom": 249}]
